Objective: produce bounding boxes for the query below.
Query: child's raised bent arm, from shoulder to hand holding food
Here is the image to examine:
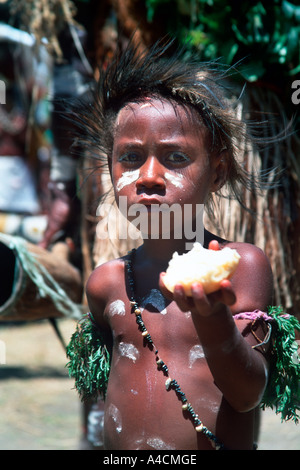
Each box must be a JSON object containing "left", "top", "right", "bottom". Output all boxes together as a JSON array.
[{"left": 161, "top": 245, "right": 272, "bottom": 412}]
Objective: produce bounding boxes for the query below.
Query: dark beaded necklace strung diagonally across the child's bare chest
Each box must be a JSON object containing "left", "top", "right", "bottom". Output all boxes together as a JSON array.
[{"left": 126, "top": 248, "right": 225, "bottom": 450}]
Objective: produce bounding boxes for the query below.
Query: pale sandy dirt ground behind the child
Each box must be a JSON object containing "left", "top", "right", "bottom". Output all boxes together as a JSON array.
[{"left": 0, "top": 319, "right": 300, "bottom": 450}]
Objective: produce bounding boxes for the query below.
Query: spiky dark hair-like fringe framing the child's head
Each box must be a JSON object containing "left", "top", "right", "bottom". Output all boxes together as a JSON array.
[{"left": 69, "top": 41, "right": 274, "bottom": 215}]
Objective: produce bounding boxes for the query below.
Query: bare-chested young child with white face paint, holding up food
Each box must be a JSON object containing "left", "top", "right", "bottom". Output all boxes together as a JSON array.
[{"left": 67, "top": 42, "right": 298, "bottom": 450}]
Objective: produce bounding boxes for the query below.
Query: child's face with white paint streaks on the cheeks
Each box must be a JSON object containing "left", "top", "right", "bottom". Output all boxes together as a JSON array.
[{"left": 111, "top": 98, "right": 223, "bottom": 235}]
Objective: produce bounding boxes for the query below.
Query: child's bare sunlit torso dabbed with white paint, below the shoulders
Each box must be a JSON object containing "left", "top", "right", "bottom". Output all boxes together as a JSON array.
[{"left": 106, "top": 293, "right": 221, "bottom": 449}]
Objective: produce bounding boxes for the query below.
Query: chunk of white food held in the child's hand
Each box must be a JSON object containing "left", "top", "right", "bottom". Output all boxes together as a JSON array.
[{"left": 163, "top": 242, "right": 240, "bottom": 296}]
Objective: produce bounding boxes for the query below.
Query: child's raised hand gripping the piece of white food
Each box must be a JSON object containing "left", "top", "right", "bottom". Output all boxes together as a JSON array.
[{"left": 159, "top": 240, "right": 236, "bottom": 316}]
